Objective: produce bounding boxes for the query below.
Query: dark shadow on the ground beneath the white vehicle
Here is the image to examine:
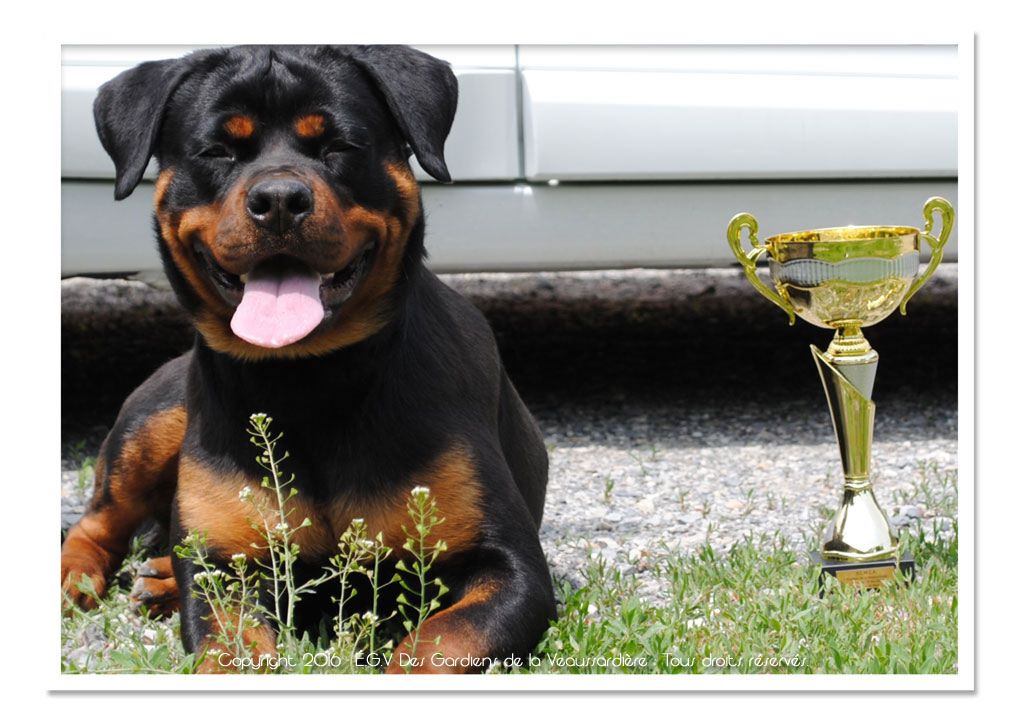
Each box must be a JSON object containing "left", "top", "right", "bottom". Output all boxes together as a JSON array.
[{"left": 61, "top": 265, "right": 957, "bottom": 441}]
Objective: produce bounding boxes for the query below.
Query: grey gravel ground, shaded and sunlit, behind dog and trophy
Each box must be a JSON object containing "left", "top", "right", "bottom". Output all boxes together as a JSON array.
[{"left": 61, "top": 264, "right": 957, "bottom": 599}]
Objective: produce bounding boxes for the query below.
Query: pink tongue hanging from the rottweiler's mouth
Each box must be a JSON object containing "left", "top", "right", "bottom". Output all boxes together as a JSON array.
[{"left": 231, "top": 267, "right": 324, "bottom": 349}]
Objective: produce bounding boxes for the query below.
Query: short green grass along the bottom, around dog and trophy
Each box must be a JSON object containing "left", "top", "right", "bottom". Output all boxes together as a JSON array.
[{"left": 62, "top": 518, "right": 957, "bottom": 674}]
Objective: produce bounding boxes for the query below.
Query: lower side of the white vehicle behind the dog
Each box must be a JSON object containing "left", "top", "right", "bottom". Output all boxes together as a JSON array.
[{"left": 61, "top": 45, "right": 961, "bottom": 275}]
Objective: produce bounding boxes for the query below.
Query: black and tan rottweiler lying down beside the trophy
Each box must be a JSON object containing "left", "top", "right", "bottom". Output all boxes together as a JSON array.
[{"left": 60, "top": 46, "right": 555, "bottom": 673}]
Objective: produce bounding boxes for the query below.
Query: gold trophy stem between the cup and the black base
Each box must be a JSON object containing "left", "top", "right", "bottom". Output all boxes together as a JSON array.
[{"left": 811, "top": 342, "right": 898, "bottom": 562}]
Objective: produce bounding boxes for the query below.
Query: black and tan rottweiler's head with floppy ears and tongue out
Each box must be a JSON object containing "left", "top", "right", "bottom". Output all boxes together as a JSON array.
[{"left": 93, "top": 46, "right": 458, "bottom": 359}]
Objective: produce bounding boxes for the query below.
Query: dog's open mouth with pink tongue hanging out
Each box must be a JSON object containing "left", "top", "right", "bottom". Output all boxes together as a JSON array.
[{"left": 199, "top": 244, "right": 376, "bottom": 349}]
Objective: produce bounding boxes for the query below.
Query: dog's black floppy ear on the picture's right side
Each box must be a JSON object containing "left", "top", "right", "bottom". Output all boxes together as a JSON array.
[{"left": 346, "top": 45, "right": 459, "bottom": 183}]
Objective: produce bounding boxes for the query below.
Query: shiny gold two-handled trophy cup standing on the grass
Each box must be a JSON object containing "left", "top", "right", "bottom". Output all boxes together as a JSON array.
[{"left": 727, "top": 197, "right": 953, "bottom": 588}]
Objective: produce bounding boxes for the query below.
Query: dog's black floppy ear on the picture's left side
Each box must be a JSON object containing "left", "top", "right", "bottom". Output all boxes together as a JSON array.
[{"left": 92, "top": 59, "right": 187, "bottom": 201}]
